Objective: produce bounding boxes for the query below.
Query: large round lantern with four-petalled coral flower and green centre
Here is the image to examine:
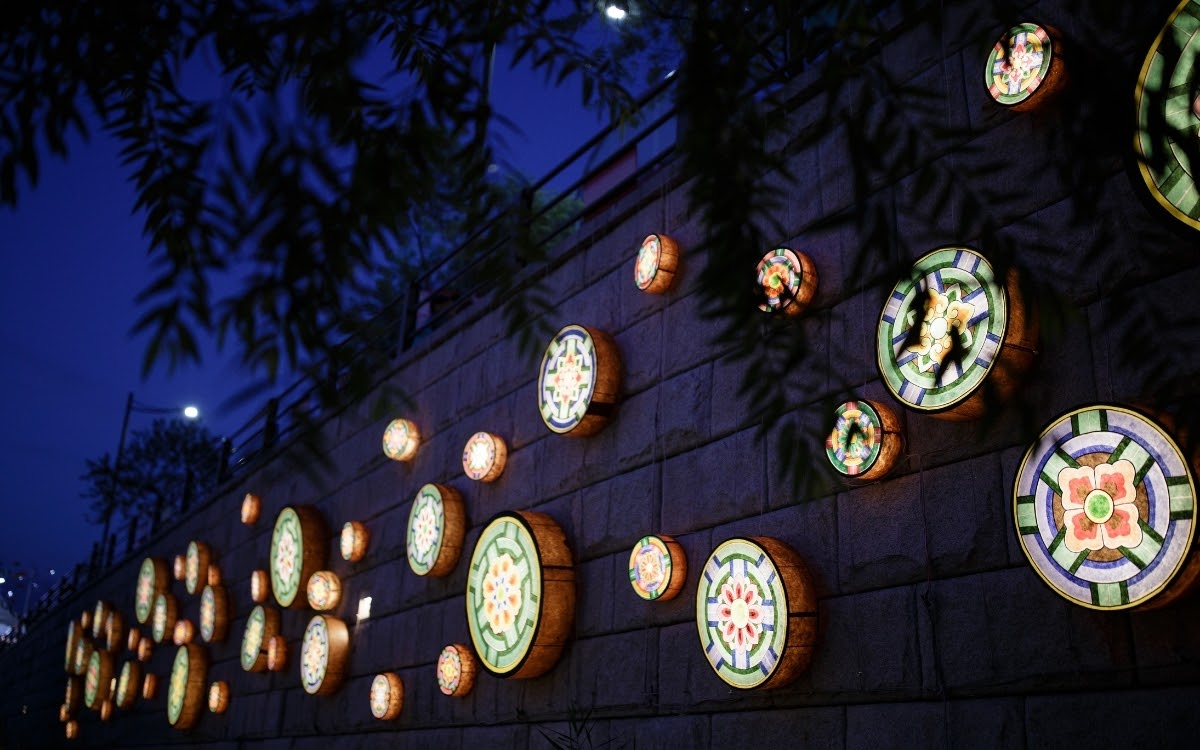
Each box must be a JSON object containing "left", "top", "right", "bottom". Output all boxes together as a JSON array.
[{"left": 1013, "top": 406, "right": 1200, "bottom": 610}]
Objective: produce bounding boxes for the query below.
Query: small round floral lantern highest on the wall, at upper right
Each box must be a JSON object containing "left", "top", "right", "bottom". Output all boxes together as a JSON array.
[{"left": 983, "top": 23, "right": 1067, "bottom": 112}]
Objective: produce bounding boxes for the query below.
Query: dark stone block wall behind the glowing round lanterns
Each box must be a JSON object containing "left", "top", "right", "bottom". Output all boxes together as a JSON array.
[{"left": 0, "top": 0, "right": 1200, "bottom": 750}]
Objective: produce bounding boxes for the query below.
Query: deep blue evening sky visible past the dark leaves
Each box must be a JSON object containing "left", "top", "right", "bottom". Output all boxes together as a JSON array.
[{"left": 0, "top": 38, "right": 600, "bottom": 608}]
